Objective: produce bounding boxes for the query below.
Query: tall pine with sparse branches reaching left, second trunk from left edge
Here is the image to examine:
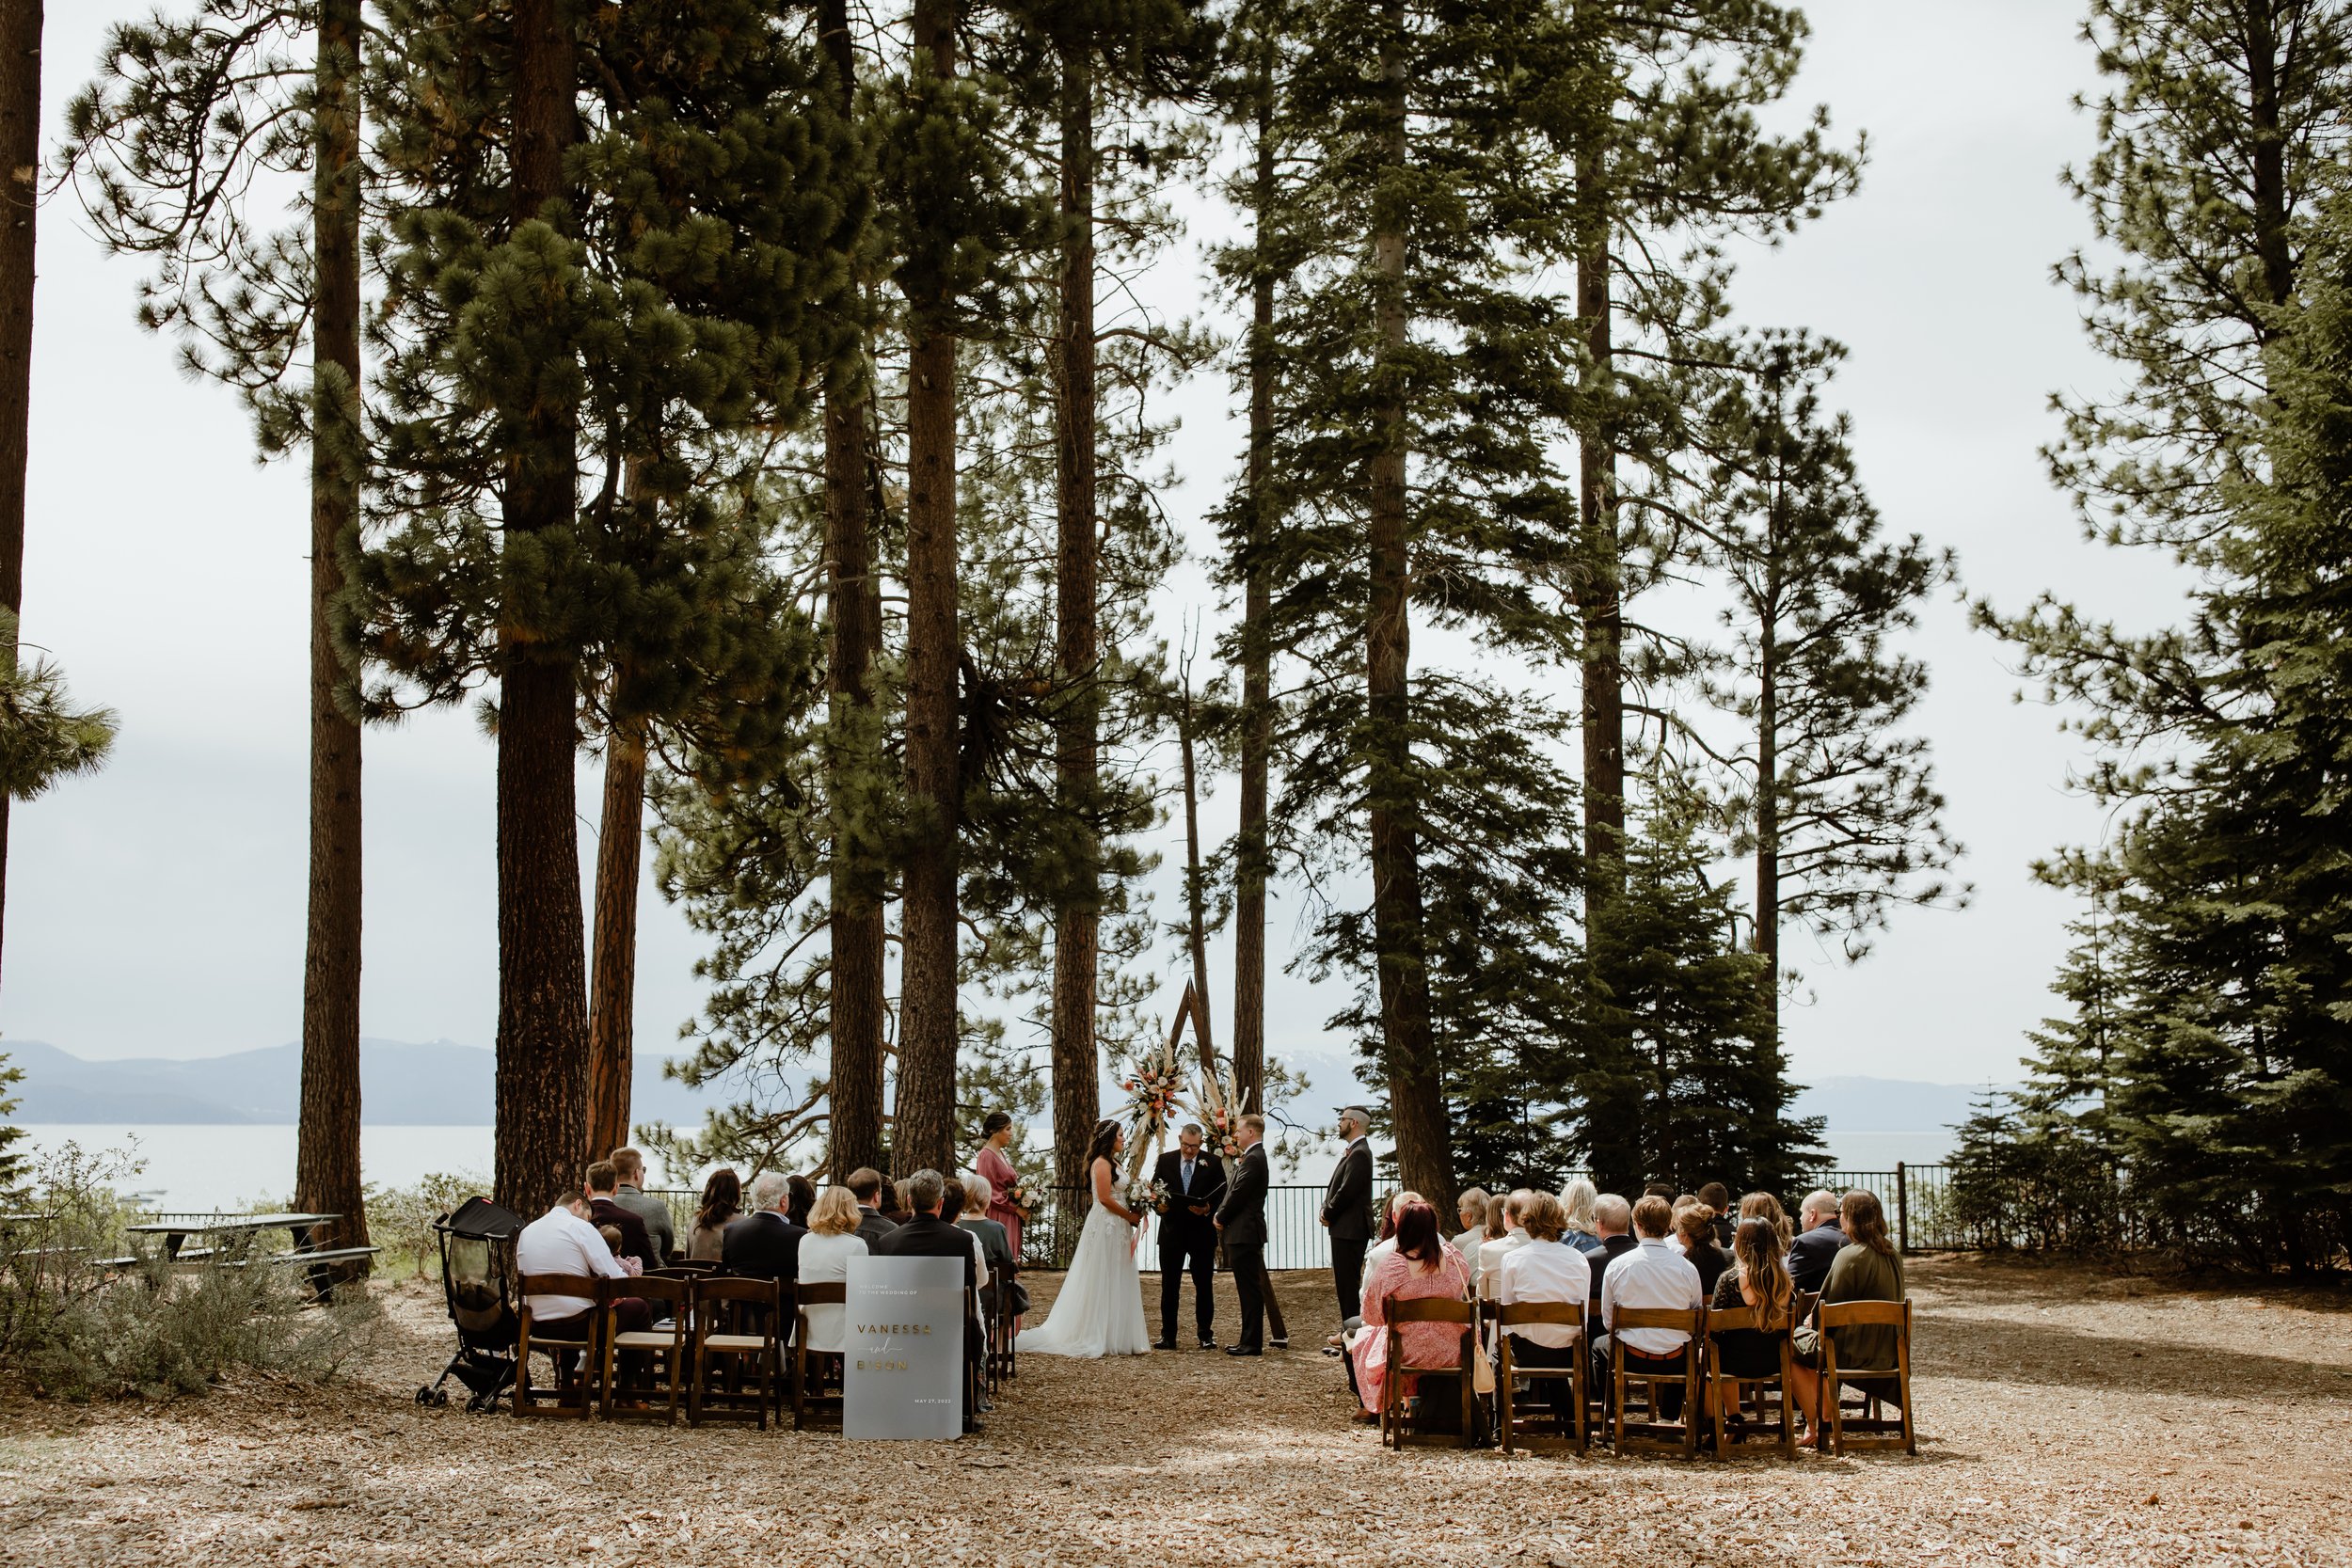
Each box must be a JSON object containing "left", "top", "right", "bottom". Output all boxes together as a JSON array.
[{"left": 66, "top": 0, "right": 367, "bottom": 1243}]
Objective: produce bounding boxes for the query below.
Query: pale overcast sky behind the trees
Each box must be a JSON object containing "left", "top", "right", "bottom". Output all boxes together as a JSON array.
[{"left": 0, "top": 0, "right": 2178, "bottom": 1098}]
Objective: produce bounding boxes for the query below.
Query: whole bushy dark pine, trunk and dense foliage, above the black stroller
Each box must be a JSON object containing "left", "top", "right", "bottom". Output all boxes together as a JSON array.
[{"left": 367, "top": 0, "right": 859, "bottom": 1209}]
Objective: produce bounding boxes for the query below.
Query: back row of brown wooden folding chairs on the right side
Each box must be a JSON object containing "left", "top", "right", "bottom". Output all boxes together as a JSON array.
[{"left": 1378, "top": 1298, "right": 1919, "bottom": 1458}]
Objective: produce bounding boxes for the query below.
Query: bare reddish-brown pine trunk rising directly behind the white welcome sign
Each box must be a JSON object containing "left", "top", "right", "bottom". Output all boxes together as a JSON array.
[{"left": 892, "top": 0, "right": 962, "bottom": 1173}]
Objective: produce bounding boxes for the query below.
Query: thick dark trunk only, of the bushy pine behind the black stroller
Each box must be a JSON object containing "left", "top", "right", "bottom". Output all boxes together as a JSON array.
[{"left": 497, "top": 0, "right": 588, "bottom": 1215}]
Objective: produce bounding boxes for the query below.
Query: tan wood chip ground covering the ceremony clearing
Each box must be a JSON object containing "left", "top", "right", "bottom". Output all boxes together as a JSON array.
[{"left": 0, "top": 1258, "right": 2352, "bottom": 1568}]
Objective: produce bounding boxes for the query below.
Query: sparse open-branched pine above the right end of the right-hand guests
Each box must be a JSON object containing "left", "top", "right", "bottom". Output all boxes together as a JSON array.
[{"left": 1692, "top": 334, "right": 1966, "bottom": 1100}]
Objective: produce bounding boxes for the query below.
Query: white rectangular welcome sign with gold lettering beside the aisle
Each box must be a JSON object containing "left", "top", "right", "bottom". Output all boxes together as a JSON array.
[{"left": 842, "top": 1258, "right": 964, "bottom": 1439}]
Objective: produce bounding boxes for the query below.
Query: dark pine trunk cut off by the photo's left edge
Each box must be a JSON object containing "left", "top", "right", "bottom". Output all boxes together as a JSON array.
[{"left": 0, "top": 0, "right": 42, "bottom": 991}]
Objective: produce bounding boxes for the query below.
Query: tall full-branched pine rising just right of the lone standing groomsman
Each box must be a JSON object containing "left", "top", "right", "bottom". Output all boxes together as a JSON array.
[{"left": 1270, "top": 0, "right": 1583, "bottom": 1204}]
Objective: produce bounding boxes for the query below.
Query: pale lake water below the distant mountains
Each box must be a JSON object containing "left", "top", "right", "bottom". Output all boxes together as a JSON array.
[{"left": 19, "top": 1124, "right": 1952, "bottom": 1209}]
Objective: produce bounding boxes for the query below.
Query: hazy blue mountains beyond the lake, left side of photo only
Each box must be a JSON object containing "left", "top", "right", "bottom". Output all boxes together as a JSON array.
[{"left": 0, "top": 1039, "right": 706, "bottom": 1126}]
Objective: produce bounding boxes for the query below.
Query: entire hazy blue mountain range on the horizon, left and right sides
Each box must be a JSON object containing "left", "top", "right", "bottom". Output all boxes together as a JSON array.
[{"left": 0, "top": 1039, "right": 1985, "bottom": 1133}]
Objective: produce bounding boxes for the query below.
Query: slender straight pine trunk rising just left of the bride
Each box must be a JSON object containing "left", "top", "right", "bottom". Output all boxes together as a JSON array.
[{"left": 1054, "top": 40, "right": 1101, "bottom": 1190}]
